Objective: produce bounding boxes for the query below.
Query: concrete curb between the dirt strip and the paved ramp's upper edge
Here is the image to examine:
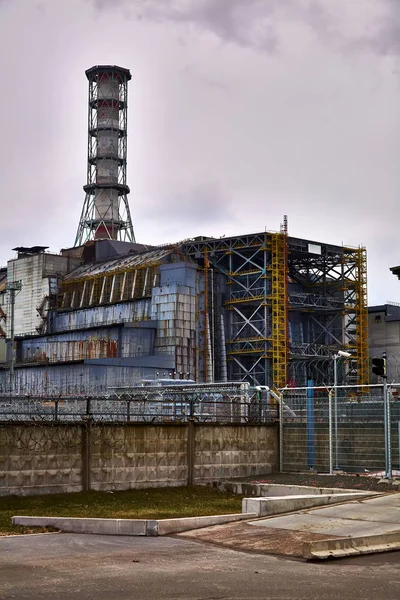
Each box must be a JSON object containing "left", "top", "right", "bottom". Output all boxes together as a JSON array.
[{"left": 242, "top": 492, "right": 370, "bottom": 517}]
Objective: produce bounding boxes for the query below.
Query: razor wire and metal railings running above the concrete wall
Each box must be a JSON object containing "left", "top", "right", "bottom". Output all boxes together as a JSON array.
[{"left": 0, "top": 384, "right": 278, "bottom": 425}]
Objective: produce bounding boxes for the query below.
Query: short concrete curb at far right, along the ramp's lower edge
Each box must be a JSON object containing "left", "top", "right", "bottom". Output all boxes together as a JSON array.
[{"left": 303, "top": 530, "right": 400, "bottom": 560}]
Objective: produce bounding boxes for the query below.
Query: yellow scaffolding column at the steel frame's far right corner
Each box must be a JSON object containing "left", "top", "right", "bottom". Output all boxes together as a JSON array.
[{"left": 356, "top": 246, "right": 369, "bottom": 385}]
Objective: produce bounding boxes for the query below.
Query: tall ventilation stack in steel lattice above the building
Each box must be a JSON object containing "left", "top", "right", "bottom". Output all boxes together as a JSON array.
[{"left": 75, "top": 65, "right": 135, "bottom": 246}]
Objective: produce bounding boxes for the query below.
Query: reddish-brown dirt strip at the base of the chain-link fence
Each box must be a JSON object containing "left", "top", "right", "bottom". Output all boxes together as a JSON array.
[{"left": 242, "top": 471, "right": 400, "bottom": 492}]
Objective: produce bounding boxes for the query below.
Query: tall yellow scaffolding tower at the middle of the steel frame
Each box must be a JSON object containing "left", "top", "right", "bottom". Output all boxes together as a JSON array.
[{"left": 271, "top": 232, "right": 288, "bottom": 388}]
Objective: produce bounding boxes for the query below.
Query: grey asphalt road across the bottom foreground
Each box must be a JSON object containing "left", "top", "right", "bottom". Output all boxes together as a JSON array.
[{"left": 0, "top": 533, "right": 400, "bottom": 600}]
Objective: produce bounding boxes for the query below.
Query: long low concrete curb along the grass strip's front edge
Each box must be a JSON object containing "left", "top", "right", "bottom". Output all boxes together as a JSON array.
[{"left": 12, "top": 513, "right": 257, "bottom": 536}]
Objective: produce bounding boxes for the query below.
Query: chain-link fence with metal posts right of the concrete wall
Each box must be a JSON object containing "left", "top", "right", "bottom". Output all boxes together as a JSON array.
[{"left": 280, "top": 384, "right": 400, "bottom": 477}]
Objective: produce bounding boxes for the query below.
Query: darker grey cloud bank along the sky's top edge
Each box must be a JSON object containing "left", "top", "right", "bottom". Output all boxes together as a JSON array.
[{"left": 90, "top": 0, "right": 400, "bottom": 55}]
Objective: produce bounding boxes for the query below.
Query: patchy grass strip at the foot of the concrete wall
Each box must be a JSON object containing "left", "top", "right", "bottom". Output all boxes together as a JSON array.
[{"left": 0, "top": 486, "right": 243, "bottom": 535}]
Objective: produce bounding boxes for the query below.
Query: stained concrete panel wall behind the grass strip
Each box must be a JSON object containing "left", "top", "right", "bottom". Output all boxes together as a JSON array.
[{"left": 0, "top": 423, "right": 278, "bottom": 496}]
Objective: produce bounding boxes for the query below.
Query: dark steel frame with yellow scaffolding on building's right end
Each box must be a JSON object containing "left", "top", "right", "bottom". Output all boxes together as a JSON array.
[{"left": 182, "top": 232, "right": 368, "bottom": 387}]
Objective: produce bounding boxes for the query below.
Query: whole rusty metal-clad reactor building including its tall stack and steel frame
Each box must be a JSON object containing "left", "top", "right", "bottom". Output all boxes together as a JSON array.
[{"left": 0, "top": 65, "right": 369, "bottom": 395}]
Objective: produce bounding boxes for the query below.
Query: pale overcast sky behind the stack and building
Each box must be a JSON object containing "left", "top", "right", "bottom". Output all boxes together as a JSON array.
[{"left": 0, "top": 0, "right": 400, "bottom": 304}]
